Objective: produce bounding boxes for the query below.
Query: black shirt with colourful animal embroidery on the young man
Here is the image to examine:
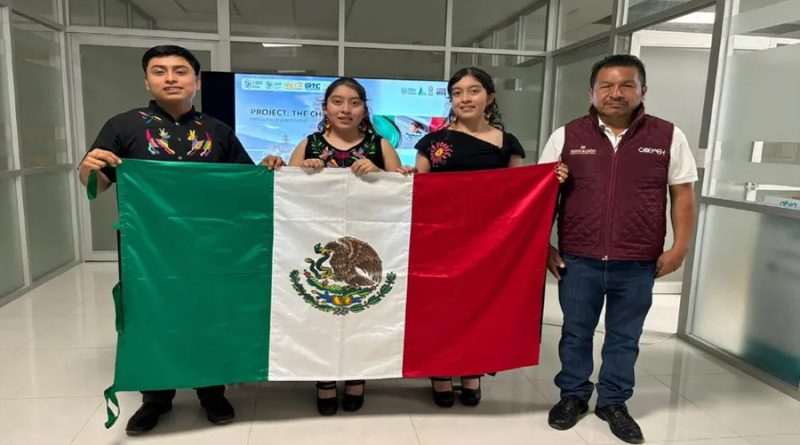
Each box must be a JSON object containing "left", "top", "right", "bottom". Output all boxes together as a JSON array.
[{"left": 89, "top": 100, "right": 253, "bottom": 182}]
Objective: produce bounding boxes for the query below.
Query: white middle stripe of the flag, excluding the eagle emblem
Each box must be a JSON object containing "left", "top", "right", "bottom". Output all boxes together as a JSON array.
[{"left": 269, "top": 168, "right": 413, "bottom": 380}]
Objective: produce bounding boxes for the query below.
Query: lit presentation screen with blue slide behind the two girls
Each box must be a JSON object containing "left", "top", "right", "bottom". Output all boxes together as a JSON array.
[{"left": 201, "top": 72, "right": 450, "bottom": 165}]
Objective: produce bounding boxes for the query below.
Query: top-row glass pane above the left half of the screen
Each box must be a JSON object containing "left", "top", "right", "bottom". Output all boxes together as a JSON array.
[{"left": 230, "top": 0, "right": 336, "bottom": 40}]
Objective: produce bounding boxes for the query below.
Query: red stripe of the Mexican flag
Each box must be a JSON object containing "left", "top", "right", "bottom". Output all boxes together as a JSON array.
[{"left": 403, "top": 164, "right": 558, "bottom": 377}]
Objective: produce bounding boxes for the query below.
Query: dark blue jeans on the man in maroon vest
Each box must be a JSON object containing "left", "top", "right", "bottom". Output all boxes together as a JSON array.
[{"left": 555, "top": 254, "right": 656, "bottom": 408}]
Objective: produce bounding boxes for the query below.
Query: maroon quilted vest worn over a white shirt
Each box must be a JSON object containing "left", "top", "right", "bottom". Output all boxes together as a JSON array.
[{"left": 558, "top": 106, "right": 674, "bottom": 260}]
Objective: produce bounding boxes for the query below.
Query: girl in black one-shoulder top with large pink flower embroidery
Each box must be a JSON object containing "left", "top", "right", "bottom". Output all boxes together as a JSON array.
[{"left": 412, "top": 67, "right": 569, "bottom": 408}]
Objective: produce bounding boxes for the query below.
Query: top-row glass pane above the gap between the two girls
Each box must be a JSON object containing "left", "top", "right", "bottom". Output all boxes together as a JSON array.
[{"left": 345, "top": 0, "right": 446, "bottom": 45}]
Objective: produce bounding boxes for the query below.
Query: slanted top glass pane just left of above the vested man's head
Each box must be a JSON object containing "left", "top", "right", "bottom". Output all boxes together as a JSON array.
[{"left": 558, "top": 0, "right": 614, "bottom": 48}]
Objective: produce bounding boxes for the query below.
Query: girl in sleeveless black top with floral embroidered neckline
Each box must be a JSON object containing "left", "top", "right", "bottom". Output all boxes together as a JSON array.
[{"left": 261, "top": 77, "right": 401, "bottom": 416}]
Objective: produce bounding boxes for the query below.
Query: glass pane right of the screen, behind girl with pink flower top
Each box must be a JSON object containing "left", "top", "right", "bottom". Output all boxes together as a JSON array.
[{"left": 451, "top": 53, "right": 544, "bottom": 158}]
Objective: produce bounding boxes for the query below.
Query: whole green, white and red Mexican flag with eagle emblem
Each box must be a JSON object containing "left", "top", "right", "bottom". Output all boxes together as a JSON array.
[{"left": 106, "top": 160, "right": 558, "bottom": 424}]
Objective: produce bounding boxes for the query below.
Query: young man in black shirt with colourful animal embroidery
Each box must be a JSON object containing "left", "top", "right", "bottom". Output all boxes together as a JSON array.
[{"left": 78, "top": 45, "right": 253, "bottom": 435}]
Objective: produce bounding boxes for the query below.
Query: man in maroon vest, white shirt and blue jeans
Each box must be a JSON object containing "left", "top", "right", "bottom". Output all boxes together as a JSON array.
[{"left": 540, "top": 55, "right": 697, "bottom": 443}]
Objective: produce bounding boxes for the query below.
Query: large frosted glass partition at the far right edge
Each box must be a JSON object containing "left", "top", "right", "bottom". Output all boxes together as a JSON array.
[{"left": 682, "top": 0, "right": 800, "bottom": 395}]
